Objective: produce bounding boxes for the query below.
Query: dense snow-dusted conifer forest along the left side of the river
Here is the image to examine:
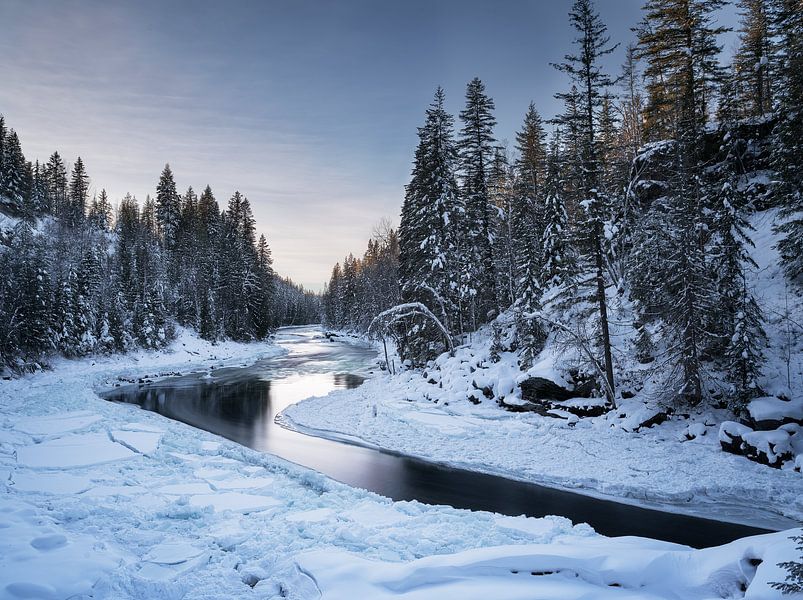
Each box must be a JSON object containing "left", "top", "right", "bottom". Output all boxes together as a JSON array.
[{"left": 0, "top": 123, "right": 320, "bottom": 370}]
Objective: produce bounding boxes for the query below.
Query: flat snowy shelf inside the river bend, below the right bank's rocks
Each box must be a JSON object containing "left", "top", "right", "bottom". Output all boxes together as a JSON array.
[{"left": 282, "top": 372, "right": 803, "bottom": 529}]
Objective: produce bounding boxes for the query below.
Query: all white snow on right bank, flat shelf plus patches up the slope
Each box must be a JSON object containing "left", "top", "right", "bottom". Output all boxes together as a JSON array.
[{"left": 282, "top": 210, "right": 803, "bottom": 529}]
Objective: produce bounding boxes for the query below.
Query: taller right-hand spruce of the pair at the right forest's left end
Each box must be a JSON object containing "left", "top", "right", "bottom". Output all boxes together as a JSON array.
[{"left": 459, "top": 77, "right": 497, "bottom": 328}]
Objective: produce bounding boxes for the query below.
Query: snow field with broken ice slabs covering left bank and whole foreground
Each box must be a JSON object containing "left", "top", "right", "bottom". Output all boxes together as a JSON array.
[{"left": 0, "top": 326, "right": 799, "bottom": 600}]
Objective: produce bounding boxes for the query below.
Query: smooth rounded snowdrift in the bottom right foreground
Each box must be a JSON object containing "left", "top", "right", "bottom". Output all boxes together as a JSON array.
[{"left": 298, "top": 535, "right": 803, "bottom": 600}]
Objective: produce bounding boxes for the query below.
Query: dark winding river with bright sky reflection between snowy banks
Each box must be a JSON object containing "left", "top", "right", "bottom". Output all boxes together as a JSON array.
[{"left": 105, "top": 327, "right": 780, "bottom": 547}]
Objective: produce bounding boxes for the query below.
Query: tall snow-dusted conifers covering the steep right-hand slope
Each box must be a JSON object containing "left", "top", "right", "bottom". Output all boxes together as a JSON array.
[{"left": 329, "top": 0, "right": 803, "bottom": 410}]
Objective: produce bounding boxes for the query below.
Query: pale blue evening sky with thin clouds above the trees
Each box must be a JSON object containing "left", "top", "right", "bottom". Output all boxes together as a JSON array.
[{"left": 0, "top": 0, "right": 736, "bottom": 290}]
